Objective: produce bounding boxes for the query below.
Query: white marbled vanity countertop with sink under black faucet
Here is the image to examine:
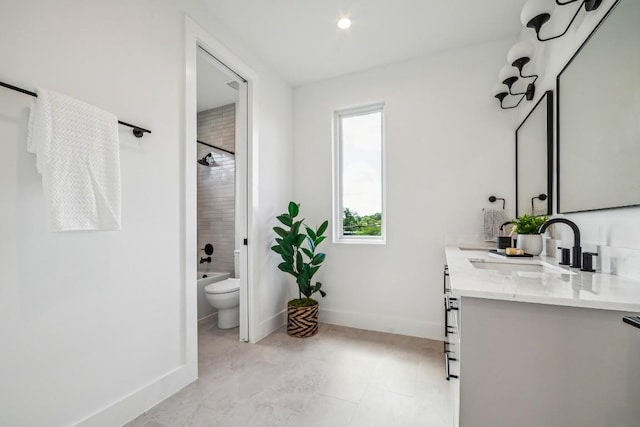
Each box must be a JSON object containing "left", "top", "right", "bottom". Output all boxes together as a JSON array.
[{"left": 445, "top": 246, "right": 640, "bottom": 312}]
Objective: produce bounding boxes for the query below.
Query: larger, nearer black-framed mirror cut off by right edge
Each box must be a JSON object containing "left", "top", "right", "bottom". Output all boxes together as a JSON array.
[{"left": 557, "top": 0, "right": 640, "bottom": 213}]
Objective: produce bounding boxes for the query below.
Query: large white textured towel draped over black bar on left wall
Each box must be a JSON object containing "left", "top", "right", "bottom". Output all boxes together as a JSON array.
[{"left": 27, "top": 89, "right": 121, "bottom": 231}]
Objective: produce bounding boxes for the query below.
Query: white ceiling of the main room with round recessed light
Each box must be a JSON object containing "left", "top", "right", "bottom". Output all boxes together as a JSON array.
[{"left": 200, "top": 0, "right": 525, "bottom": 86}]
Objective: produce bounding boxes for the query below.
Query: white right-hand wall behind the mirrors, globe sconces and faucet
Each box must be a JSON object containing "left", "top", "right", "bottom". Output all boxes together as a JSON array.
[{"left": 518, "top": 0, "right": 640, "bottom": 279}]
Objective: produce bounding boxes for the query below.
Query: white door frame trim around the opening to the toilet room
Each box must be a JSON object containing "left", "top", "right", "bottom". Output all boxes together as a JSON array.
[{"left": 181, "top": 16, "right": 257, "bottom": 372}]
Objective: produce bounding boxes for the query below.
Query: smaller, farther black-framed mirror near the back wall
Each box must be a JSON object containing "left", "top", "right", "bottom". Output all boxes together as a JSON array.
[{"left": 516, "top": 91, "right": 553, "bottom": 217}]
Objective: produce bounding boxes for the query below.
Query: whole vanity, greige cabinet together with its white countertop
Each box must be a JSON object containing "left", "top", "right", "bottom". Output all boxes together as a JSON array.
[{"left": 445, "top": 248, "right": 640, "bottom": 427}]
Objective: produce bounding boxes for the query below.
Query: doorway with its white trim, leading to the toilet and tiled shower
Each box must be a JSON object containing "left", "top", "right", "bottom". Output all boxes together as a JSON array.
[{"left": 184, "top": 18, "right": 252, "bottom": 352}]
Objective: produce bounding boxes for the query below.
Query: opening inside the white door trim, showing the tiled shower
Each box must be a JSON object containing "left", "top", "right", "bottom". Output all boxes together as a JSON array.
[{"left": 194, "top": 45, "right": 249, "bottom": 341}]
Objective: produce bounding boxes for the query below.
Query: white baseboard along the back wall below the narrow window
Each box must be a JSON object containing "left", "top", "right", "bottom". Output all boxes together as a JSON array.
[{"left": 319, "top": 308, "right": 444, "bottom": 341}]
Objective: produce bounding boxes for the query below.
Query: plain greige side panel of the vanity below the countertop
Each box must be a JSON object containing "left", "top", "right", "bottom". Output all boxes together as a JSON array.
[{"left": 459, "top": 297, "right": 640, "bottom": 427}]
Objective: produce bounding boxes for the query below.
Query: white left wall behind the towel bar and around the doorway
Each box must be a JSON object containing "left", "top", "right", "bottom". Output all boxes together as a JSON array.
[{"left": 0, "top": 0, "right": 292, "bottom": 426}]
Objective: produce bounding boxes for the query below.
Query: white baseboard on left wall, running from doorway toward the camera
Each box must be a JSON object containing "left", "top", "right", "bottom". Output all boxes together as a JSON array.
[{"left": 74, "top": 365, "right": 198, "bottom": 427}]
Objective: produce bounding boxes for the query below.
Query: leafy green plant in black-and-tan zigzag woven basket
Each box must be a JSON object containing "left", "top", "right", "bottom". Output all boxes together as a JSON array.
[{"left": 271, "top": 202, "right": 329, "bottom": 338}]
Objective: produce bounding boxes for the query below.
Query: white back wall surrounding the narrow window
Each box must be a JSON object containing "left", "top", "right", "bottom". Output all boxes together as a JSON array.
[{"left": 294, "top": 40, "right": 516, "bottom": 339}]
